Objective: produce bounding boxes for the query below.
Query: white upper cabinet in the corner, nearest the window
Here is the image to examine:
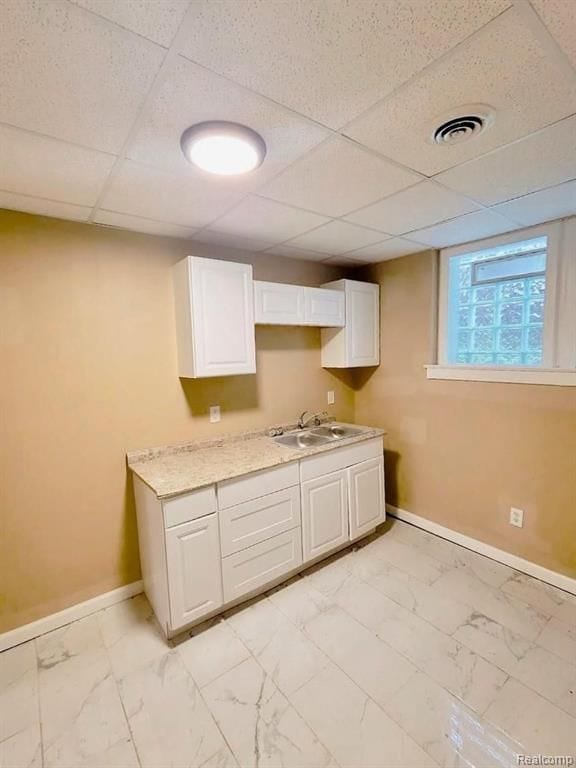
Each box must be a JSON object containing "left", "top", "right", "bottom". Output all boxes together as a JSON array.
[{"left": 322, "top": 280, "right": 380, "bottom": 368}]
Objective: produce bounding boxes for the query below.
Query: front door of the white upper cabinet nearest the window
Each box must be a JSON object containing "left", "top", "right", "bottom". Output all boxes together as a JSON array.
[{"left": 346, "top": 280, "right": 380, "bottom": 368}]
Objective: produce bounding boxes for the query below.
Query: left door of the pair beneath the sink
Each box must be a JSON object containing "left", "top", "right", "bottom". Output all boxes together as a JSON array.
[{"left": 302, "top": 469, "right": 348, "bottom": 562}]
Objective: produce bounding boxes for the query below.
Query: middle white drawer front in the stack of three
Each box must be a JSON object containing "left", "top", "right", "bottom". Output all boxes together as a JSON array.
[{"left": 220, "top": 485, "right": 300, "bottom": 556}]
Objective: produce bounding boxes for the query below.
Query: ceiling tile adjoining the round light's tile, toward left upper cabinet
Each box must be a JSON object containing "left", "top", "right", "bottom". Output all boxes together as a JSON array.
[{"left": 101, "top": 160, "right": 245, "bottom": 227}]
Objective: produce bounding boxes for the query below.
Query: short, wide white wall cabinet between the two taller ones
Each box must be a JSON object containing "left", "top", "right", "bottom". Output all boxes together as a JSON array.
[{"left": 254, "top": 281, "right": 346, "bottom": 327}]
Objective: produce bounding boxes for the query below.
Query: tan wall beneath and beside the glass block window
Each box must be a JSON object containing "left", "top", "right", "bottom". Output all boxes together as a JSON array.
[{"left": 355, "top": 252, "right": 576, "bottom": 576}]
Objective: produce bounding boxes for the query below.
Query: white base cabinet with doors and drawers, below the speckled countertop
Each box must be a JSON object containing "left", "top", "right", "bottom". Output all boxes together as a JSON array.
[{"left": 134, "top": 437, "right": 386, "bottom": 638}]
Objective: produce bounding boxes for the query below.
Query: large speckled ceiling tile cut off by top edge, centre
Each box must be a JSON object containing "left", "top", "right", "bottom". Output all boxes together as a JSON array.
[{"left": 176, "top": 0, "right": 510, "bottom": 128}]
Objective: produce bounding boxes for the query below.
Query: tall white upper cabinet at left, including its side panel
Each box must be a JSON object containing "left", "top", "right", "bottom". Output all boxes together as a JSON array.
[{"left": 174, "top": 256, "right": 256, "bottom": 379}]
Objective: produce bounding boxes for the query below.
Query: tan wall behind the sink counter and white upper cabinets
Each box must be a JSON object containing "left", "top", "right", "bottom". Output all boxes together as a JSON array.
[{"left": 0, "top": 211, "right": 353, "bottom": 631}]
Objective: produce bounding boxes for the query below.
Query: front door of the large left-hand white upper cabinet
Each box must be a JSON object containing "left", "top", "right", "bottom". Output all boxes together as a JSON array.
[{"left": 188, "top": 256, "right": 256, "bottom": 378}]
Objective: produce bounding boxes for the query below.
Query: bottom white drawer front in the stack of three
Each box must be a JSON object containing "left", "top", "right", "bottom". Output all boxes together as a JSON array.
[{"left": 222, "top": 528, "right": 302, "bottom": 603}]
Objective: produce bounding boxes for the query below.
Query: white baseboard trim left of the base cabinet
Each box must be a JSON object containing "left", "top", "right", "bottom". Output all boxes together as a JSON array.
[{"left": 0, "top": 581, "right": 144, "bottom": 652}]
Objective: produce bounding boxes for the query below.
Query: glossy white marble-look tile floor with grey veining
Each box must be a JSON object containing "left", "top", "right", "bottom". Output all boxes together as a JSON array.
[{"left": 0, "top": 521, "right": 576, "bottom": 768}]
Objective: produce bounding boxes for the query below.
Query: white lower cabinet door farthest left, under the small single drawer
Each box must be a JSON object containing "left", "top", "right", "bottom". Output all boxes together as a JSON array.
[{"left": 166, "top": 514, "right": 222, "bottom": 631}]
